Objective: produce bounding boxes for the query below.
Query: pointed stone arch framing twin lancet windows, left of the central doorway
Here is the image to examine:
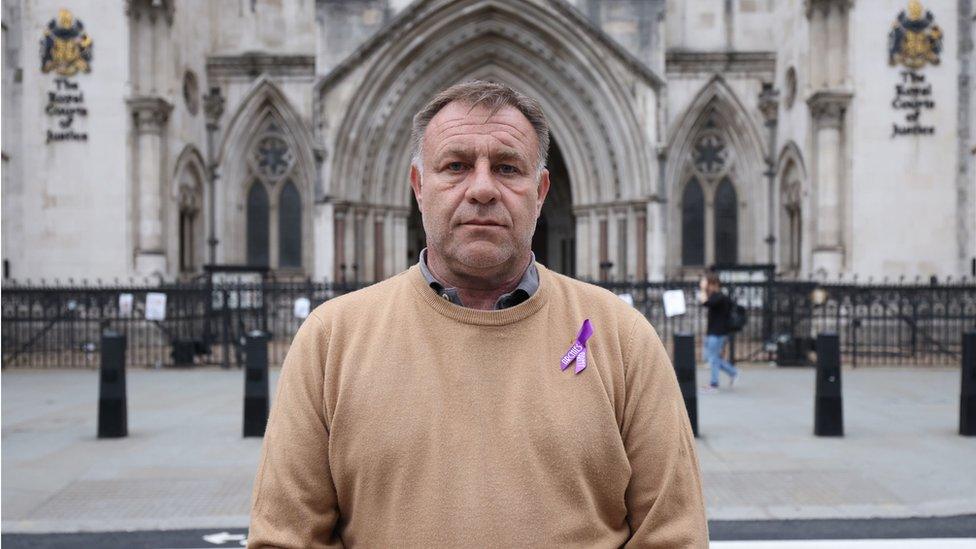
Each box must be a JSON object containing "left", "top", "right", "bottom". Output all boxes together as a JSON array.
[{"left": 218, "top": 74, "right": 317, "bottom": 268}]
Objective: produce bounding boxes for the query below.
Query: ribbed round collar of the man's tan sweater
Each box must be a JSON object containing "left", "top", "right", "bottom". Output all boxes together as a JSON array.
[{"left": 407, "top": 263, "right": 552, "bottom": 326}]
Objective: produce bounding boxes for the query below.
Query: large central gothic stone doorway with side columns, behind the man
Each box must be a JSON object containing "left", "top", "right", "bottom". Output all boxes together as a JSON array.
[{"left": 315, "top": 0, "right": 664, "bottom": 279}]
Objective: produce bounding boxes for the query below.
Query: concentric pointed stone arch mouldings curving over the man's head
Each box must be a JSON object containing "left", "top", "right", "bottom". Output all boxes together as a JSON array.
[{"left": 316, "top": 0, "right": 660, "bottom": 212}]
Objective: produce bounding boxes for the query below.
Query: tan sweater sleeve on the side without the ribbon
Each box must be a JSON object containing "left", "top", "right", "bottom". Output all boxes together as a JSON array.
[{"left": 247, "top": 313, "right": 342, "bottom": 548}]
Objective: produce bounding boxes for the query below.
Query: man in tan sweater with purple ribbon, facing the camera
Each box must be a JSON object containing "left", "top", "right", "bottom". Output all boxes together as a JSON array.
[{"left": 248, "top": 82, "right": 708, "bottom": 548}]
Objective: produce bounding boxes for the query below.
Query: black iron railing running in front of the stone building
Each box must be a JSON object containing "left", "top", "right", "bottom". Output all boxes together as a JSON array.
[{"left": 0, "top": 280, "right": 976, "bottom": 368}]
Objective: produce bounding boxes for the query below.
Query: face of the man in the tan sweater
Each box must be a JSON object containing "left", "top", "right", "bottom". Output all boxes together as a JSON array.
[{"left": 410, "top": 103, "right": 549, "bottom": 277}]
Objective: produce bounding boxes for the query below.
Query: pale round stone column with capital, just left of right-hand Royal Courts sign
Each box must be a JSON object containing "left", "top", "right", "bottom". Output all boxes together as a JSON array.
[{"left": 808, "top": 92, "right": 851, "bottom": 276}]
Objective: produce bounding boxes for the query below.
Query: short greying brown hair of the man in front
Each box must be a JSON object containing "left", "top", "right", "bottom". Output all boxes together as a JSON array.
[{"left": 410, "top": 80, "right": 549, "bottom": 173}]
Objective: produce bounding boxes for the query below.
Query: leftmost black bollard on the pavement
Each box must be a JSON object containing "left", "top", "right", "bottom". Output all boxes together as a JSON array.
[{"left": 98, "top": 330, "right": 129, "bottom": 438}]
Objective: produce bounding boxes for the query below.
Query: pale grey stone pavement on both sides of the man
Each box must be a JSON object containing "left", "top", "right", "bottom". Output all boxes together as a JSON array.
[{"left": 2, "top": 365, "right": 976, "bottom": 534}]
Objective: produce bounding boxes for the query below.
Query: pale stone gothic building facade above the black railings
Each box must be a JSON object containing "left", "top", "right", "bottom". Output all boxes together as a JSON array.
[{"left": 2, "top": 0, "right": 976, "bottom": 280}]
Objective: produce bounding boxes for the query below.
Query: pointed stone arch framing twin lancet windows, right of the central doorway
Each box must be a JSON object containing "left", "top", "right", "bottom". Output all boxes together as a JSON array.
[{"left": 665, "top": 75, "right": 768, "bottom": 272}]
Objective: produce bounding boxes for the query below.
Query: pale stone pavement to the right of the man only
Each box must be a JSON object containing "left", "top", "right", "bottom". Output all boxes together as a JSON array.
[{"left": 698, "top": 365, "right": 976, "bottom": 520}]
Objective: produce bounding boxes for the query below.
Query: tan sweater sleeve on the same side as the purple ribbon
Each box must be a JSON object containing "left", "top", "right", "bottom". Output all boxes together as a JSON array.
[{"left": 621, "top": 316, "right": 708, "bottom": 548}]
